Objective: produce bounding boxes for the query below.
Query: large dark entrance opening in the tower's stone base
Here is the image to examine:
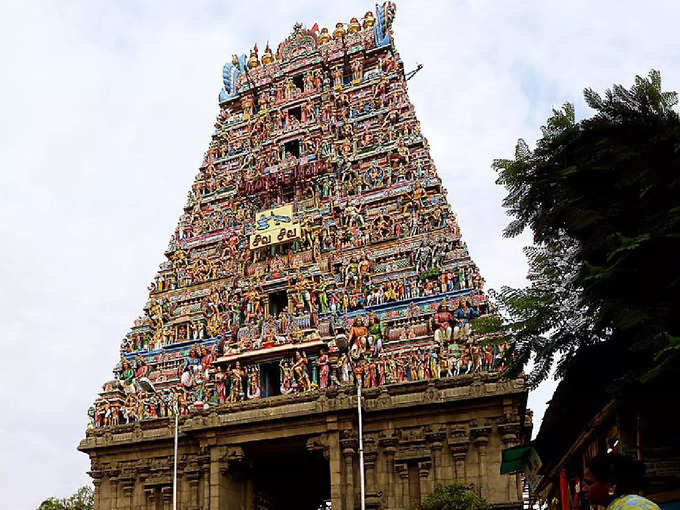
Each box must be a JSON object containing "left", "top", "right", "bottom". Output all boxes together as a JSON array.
[{"left": 244, "top": 437, "right": 331, "bottom": 510}]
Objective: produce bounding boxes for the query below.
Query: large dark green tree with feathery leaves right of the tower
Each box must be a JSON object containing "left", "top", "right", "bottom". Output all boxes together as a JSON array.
[{"left": 490, "top": 71, "right": 680, "bottom": 386}]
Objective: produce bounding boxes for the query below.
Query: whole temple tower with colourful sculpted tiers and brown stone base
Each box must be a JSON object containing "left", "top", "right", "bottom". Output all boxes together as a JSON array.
[{"left": 79, "top": 2, "right": 531, "bottom": 510}]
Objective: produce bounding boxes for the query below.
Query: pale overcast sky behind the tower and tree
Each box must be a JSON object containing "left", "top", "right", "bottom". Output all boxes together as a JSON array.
[{"left": 0, "top": 0, "right": 680, "bottom": 509}]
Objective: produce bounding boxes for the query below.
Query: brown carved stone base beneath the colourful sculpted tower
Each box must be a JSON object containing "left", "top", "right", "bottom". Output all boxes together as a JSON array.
[{"left": 79, "top": 374, "right": 531, "bottom": 510}]
